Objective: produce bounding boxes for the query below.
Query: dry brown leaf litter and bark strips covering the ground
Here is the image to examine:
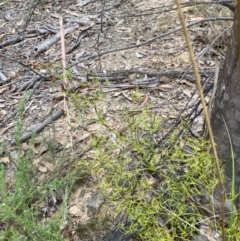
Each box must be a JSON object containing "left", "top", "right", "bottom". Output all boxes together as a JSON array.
[{"left": 0, "top": 0, "right": 233, "bottom": 240}]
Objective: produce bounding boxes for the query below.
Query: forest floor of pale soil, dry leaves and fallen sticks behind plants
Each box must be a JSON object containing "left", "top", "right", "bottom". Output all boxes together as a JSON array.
[{"left": 0, "top": 0, "right": 232, "bottom": 240}]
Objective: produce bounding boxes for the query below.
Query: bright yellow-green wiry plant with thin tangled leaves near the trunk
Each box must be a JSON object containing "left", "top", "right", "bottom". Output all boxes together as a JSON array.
[{"left": 82, "top": 102, "right": 217, "bottom": 241}]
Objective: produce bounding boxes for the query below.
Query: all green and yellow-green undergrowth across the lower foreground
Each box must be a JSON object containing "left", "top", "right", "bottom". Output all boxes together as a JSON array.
[{"left": 0, "top": 81, "right": 239, "bottom": 241}]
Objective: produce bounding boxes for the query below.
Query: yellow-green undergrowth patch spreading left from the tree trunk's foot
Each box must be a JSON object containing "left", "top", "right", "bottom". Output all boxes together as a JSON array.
[{"left": 71, "top": 82, "right": 236, "bottom": 241}]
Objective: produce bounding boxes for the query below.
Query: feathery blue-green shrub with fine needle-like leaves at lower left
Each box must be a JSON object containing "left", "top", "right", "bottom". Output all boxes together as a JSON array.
[{"left": 0, "top": 95, "right": 86, "bottom": 241}]
